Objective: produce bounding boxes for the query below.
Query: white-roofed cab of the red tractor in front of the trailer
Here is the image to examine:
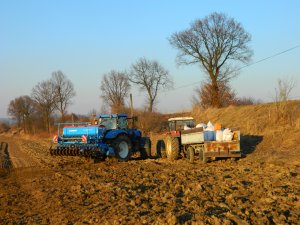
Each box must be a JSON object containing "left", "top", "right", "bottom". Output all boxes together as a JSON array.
[{"left": 167, "top": 117, "right": 195, "bottom": 136}]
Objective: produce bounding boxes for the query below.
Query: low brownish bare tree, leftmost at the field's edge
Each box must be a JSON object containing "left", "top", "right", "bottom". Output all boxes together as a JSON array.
[{"left": 7, "top": 95, "right": 36, "bottom": 133}]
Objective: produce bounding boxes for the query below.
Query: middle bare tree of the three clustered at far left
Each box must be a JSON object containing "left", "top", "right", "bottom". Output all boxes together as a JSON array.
[{"left": 31, "top": 80, "right": 57, "bottom": 133}]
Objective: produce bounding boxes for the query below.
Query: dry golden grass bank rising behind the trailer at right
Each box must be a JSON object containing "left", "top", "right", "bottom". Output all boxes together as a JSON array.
[{"left": 150, "top": 100, "right": 300, "bottom": 156}]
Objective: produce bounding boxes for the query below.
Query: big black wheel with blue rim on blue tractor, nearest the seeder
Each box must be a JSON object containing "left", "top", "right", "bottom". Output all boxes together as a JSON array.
[{"left": 112, "top": 135, "right": 132, "bottom": 161}]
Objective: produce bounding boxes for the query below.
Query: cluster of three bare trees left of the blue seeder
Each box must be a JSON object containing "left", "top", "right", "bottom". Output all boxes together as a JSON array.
[{"left": 7, "top": 70, "right": 76, "bottom": 133}]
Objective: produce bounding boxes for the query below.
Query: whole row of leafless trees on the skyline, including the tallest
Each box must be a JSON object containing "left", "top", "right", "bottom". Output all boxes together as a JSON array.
[{"left": 7, "top": 13, "right": 254, "bottom": 132}]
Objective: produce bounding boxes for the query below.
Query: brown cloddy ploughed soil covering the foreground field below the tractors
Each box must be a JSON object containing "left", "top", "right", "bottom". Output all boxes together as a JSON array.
[{"left": 0, "top": 136, "right": 300, "bottom": 224}]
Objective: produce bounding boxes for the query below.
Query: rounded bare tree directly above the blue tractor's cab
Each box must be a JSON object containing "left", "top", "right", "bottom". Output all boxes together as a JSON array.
[{"left": 100, "top": 70, "right": 130, "bottom": 113}]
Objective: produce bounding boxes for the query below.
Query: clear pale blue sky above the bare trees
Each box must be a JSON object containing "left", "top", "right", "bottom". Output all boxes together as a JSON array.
[{"left": 0, "top": 0, "right": 300, "bottom": 117}]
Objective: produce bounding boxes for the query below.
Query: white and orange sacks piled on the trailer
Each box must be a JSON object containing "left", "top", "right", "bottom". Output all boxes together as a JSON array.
[{"left": 196, "top": 121, "right": 233, "bottom": 141}]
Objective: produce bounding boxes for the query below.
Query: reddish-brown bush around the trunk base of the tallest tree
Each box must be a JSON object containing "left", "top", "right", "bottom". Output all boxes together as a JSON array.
[{"left": 193, "top": 81, "right": 236, "bottom": 108}]
